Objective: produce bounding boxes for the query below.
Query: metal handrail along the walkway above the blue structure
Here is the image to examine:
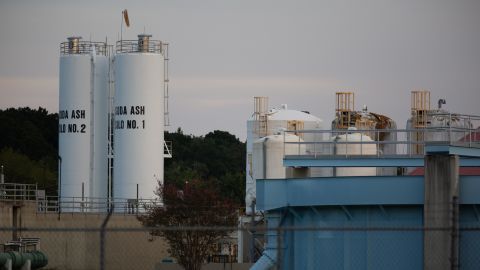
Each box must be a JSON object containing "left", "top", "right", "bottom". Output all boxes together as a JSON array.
[{"left": 284, "top": 125, "right": 480, "bottom": 158}]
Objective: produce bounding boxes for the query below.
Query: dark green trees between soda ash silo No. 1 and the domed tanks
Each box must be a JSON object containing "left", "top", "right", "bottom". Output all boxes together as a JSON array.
[{"left": 165, "top": 128, "right": 245, "bottom": 204}]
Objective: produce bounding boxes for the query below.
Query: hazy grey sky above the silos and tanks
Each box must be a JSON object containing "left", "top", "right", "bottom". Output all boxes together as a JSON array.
[{"left": 0, "top": 0, "right": 480, "bottom": 140}]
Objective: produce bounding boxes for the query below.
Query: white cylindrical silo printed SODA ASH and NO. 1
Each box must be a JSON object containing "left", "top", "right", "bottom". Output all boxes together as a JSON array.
[{"left": 112, "top": 35, "right": 164, "bottom": 199}]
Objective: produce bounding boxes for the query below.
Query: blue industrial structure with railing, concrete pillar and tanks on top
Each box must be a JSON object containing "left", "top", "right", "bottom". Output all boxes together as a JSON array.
[{"left": 248, "top": 91, "right": 480, "bottom": 269}]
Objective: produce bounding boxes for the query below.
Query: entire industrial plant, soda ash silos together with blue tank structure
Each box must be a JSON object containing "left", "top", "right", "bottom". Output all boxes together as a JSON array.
[{"left": 0, "top": 29, "right": 480, "bottom": 270}]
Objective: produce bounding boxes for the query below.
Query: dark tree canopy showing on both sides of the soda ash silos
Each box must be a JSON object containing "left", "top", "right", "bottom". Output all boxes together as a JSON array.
[{"left": 0, "top": 107, "right": 245, "bottom": 204}]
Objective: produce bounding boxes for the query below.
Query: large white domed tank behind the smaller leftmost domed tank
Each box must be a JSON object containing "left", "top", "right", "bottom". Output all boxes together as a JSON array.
[{"left": 245, "top": 97, "right": 328, "bottom": 214}]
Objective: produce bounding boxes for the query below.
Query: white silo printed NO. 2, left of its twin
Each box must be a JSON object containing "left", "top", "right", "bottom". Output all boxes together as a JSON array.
[{"left": 59, "top": 37, "right": 108, "bottom": 211}]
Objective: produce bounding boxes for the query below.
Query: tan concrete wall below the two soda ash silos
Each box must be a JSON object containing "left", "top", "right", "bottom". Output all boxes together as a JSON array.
[{"left": 0, "top": 202, "right": 169, "bottom": 270}]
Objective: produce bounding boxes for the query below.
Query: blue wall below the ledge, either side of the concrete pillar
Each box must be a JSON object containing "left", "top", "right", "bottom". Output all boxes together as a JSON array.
[{"left": 274, "top": 205, "right": 480, "bottom": 270}]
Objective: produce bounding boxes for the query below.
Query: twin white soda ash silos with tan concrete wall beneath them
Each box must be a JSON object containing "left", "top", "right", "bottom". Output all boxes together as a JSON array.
[{"left": 0, "top": 34, "right": 171, "bottom": 269}]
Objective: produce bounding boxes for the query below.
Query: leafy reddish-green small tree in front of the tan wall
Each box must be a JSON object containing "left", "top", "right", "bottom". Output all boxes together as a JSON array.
[{"left": 139, "top": 180, "right": 237, "bottom": 270}]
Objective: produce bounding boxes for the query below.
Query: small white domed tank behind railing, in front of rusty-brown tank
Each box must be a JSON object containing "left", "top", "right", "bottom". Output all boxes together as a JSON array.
[{"left": 332, "top": 128, "right": 377, "bottom": 176}]
